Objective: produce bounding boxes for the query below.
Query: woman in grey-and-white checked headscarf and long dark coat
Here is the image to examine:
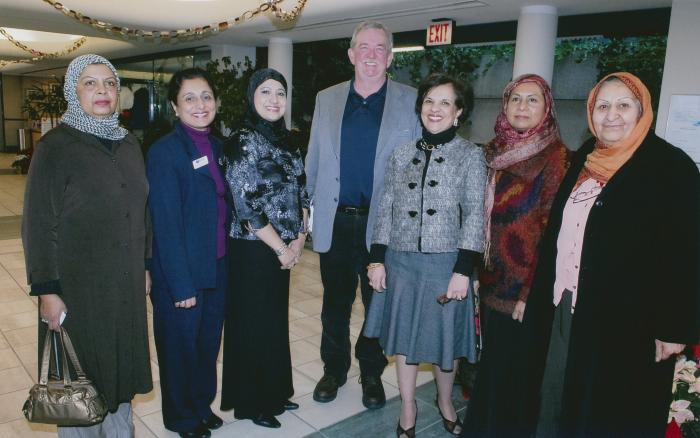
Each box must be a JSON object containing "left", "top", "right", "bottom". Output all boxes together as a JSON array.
[{"left": 22, "top": 54, "right": 153, "bottom": 438}]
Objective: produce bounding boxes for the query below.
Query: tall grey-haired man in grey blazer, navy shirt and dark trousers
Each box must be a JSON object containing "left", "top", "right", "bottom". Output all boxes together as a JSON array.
[{"left": 306, "top": 21, "right": 420, "bottom": 409}]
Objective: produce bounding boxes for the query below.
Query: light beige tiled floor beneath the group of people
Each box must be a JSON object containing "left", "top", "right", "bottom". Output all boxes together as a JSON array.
[{"left": 0, "top": 154, "right": 465, "bottom": 438}]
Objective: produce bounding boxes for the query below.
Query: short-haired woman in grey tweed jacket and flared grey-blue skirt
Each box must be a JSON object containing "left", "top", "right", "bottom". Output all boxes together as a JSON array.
[{"left": 365, "top": 74, "right": 486, "bottom": 438}]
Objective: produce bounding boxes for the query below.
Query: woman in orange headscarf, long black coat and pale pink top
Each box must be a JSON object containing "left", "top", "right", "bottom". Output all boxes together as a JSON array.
[{"left": 518, "top": 73, "right": 700, "bottom": 437}]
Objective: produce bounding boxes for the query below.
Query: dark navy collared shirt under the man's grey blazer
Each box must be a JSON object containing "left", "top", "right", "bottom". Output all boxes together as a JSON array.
[{"left": 338, "top": 79, "right": 388, "bottom": 208}]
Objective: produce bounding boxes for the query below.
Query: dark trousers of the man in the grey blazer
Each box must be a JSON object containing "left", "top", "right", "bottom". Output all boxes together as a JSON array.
[{"left": 320, "top": 212, "right": 387, "bottom": 383}]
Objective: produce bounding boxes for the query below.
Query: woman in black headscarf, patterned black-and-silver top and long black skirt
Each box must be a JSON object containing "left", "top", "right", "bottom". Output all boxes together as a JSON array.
[{"left": 221, "top": 69, "right": 309, "bottom": 428}]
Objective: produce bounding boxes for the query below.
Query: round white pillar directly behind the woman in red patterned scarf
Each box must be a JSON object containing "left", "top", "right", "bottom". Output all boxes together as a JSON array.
[{"left": 513, "top": 5, "right": 557, "bottom": 85}]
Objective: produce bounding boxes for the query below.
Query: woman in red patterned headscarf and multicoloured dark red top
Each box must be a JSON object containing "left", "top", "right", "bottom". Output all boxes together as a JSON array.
[{"left": 462, "top": 74, "right": 569, "bottom": 437}]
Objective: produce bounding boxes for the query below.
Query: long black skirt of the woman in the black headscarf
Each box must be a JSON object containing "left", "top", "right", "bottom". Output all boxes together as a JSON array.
[{"left": 221, "top": 239, "right": 294, "bottom": 418}]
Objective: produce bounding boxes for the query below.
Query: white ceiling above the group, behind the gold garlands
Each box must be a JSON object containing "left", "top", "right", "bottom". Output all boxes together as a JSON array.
[{"left": 0, "top": 0, "right": 672, "bottom": 74}]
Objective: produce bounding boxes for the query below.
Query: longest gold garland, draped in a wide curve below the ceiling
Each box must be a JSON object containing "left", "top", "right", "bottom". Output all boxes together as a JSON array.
[{"left": 44, "top": 0, "right": 308, "bottom": 41}]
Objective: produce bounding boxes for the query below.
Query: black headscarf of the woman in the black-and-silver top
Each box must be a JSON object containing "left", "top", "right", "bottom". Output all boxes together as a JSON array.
[{"left": 246, "top": 68, "right": 296, "bottom": 149}]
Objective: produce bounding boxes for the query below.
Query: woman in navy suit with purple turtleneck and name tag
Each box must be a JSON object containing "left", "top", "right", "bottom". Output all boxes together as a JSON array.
[{"left": 146, "top": 69, "right": 230, "bottom": 437}]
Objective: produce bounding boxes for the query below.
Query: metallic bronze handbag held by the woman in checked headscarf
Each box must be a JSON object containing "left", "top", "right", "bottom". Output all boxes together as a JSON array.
[{"left": 22, "top": 327, "right": 107, "bottom": 426}]
